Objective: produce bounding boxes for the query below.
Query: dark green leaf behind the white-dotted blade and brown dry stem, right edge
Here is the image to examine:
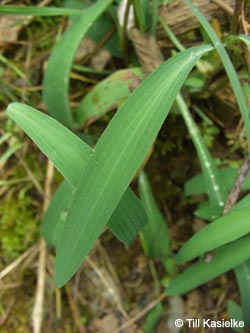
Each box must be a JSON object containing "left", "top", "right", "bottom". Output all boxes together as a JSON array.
[{"left": 185, "top": 168, "right": 250, "bottom": 195}]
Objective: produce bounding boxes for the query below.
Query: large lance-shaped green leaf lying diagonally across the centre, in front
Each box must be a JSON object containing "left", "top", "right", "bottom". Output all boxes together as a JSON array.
[{"left": 55, "top": 46, "right": 214, "bottom": 287}]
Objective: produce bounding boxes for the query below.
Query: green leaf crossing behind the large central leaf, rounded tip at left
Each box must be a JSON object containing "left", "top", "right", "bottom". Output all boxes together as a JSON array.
[{"left": 7, "top": 103, "right": 147, "bottom": 245}]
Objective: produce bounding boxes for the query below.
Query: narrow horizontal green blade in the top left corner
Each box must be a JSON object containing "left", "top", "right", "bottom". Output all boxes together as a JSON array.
[{"left": 0, "top": 5, "right": 81, "bottom": 16}]
